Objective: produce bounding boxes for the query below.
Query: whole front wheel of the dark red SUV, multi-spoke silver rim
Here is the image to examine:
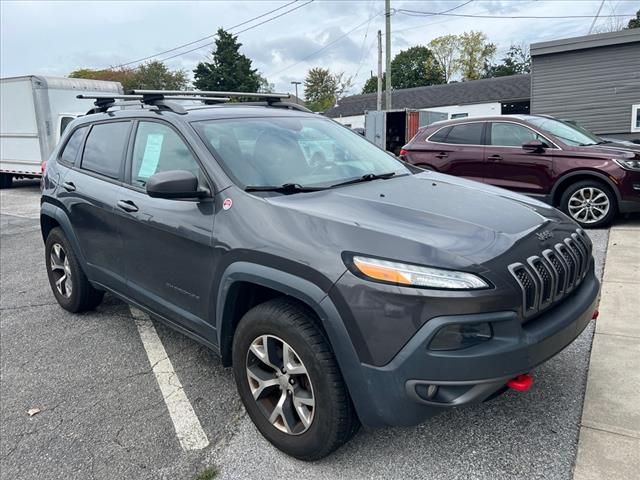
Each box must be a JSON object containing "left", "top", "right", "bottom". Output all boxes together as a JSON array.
[{"left": 560, "top": 180, "right": 618, "bottom": 228}]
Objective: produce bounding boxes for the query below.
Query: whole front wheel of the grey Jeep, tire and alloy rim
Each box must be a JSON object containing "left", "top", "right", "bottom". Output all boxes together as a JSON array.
[{"left": 233, "top": 299, "right": 360, "bottom": 460}]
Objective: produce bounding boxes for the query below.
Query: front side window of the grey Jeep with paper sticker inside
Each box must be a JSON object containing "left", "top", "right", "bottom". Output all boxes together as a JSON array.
[{"left": 131, "top": 121, "right": 203, "bottom": 187}]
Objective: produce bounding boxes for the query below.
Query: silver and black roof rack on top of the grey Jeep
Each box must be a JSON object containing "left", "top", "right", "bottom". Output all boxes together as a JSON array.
[{"left": 76, "top": 90, "right": 310, "bottom": 115}]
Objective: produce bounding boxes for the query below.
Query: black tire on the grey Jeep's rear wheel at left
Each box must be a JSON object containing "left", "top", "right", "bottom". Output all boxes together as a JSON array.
[{"left": 45, "top": 227, "right": 104, "bottom": 313}]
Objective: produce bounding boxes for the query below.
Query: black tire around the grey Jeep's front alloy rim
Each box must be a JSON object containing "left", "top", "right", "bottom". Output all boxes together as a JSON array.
[{"left": 233, "top": 298, "right": 360, "bottom": 461}]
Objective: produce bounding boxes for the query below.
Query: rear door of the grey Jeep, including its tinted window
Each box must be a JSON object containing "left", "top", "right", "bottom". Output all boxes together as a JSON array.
[{"left": 58, "top": 120, "right": 131, "bottom": 291}]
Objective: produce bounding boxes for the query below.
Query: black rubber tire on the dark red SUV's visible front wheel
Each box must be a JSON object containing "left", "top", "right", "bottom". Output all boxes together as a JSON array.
[{"left": 560, "top": 180, "right": 618, "bottom": 228}]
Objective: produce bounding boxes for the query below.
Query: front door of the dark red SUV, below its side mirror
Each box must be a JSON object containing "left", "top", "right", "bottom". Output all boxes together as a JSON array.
[{"left": 485, "top": 122, "right": 554, "bottom": 195}]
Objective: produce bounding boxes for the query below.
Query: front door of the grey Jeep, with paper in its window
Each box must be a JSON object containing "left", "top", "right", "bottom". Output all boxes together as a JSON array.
[{"left": 117, "top": 120, "right": 215, "bottom": 340}]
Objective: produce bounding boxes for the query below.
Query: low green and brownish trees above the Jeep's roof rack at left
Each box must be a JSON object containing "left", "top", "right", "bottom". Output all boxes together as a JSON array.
[{"left": 69, "top": 61, "right": 189, "bottom": 92}]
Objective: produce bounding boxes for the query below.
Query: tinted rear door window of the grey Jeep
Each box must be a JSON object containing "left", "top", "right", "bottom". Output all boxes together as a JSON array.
[{"left": 82, "top": 122, "right": 130, "bottom": 178}]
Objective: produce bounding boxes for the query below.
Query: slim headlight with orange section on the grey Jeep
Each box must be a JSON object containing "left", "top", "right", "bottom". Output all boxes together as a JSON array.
[{"left": 351, "top": 256, "right": 489, "bottom": 290}]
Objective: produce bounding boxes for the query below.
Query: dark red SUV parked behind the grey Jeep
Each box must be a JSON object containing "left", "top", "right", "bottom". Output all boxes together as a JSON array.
[{"left": 400, "top": 115, "right": 640, "bottom": 228}]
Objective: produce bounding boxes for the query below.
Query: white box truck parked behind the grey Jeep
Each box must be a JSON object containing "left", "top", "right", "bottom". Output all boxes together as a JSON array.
[{"left": 0, "top": 75, "right": 123, "bottom": 188}]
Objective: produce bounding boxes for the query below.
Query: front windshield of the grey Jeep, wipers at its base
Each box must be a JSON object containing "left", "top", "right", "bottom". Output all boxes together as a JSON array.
[{"left": 193, "top": 117, "right": 409, "bottom": 188}]
